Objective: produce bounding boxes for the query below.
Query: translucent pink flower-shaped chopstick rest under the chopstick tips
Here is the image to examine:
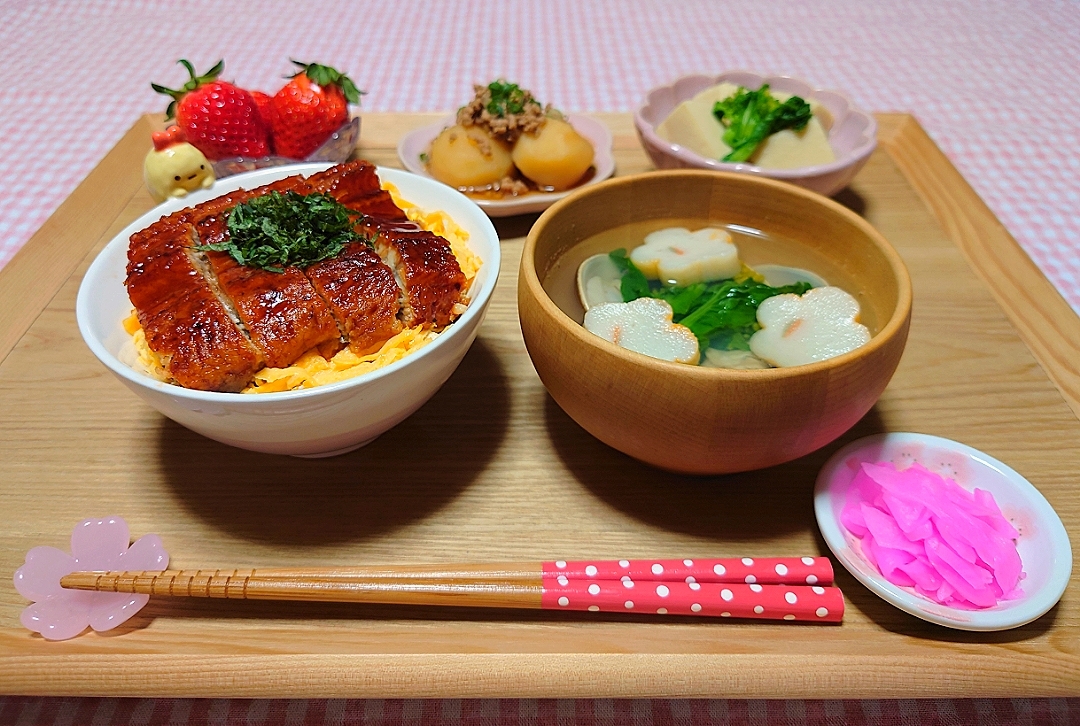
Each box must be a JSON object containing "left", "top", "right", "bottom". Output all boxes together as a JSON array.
[{"left": 15, "top": 516, "right": 168, "bottom": 641}]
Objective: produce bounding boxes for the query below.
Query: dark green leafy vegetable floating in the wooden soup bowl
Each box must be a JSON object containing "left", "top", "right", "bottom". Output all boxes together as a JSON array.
[{"left": 610, "top": 250, "right": 811, "bottom": 350}]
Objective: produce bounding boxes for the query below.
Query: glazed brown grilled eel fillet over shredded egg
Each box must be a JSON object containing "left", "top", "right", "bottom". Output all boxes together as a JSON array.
[{"left": 126, "top": 161, "right": 465, "bottom": 391}]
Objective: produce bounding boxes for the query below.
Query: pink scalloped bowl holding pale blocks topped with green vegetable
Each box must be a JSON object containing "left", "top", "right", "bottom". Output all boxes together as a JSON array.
[{"left": 634, "top": 70, "right": 877, "bottom": 196}]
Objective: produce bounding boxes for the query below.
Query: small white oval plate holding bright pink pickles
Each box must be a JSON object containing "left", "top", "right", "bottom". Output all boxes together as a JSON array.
[{"left": 813, "top": 433, "right": 1072, "bottom": 631}]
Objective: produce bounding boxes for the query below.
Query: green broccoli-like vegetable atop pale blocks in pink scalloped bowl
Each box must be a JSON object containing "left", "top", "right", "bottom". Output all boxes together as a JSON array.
[{"left": 713, "top": 83, "right": 811, "bottom": 162}]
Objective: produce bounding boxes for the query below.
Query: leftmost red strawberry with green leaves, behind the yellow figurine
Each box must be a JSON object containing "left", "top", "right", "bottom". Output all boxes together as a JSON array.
[{"left": 150, "top": 61, "right": 270, "bottom": 160}]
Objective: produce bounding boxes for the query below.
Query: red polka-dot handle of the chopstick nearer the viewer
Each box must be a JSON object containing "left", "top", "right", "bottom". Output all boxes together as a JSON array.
[{"left": 541, "top": 576, "right": 843, "bottom": 622}]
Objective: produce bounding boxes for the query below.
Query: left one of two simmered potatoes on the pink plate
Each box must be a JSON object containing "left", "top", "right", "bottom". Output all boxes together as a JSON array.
[{"left": 428, "top": 125, "right": 514, "bottom": 187}]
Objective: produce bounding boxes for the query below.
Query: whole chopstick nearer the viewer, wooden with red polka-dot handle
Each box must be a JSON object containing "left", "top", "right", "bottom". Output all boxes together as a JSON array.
[{"left": 60, "top": 563, "right": 843, "bottom": 622}]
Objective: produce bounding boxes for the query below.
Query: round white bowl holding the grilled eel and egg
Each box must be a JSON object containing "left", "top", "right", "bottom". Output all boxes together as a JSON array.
[{"left": 76, "top": 163, "right": 500, "bottom": 456}]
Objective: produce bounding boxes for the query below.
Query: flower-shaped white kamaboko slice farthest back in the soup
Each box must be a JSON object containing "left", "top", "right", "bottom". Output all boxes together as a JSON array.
[{"left": 630, "top": 227, "right": 742, "bottom": 286}]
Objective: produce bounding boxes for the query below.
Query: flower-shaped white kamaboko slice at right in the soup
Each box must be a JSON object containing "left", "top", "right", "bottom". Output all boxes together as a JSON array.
[{"left": 750, "top": 287, "right": 870, "bottom": 367}]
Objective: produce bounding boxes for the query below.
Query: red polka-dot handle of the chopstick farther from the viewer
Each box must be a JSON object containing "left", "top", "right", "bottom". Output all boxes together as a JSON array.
[{"left": 541, "top": 557, "right": 833, "bottom": 584}]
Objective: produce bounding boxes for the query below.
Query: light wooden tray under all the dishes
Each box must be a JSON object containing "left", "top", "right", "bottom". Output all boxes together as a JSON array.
[{"left": 0, "top": 115, "right": 1080, "bottom": 698}]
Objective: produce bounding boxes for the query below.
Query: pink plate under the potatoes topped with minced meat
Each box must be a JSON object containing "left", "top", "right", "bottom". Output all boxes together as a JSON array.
[{"left": 397, "top": 113, "right": 615, "bottom": 217}]
